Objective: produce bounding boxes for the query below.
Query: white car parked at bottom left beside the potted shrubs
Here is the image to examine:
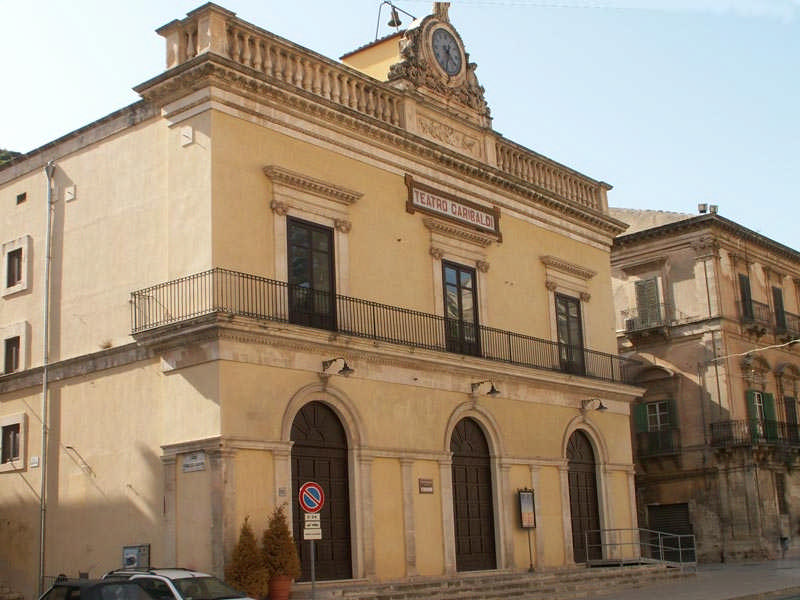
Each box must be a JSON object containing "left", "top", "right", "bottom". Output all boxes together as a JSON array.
[{"left": 103, "top": 569, "right": 252, "bottom": 600}]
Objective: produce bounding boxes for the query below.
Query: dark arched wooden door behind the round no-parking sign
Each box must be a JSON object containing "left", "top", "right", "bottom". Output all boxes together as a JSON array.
[{"left": 291, "top": 402, "right": 353, "bottom": 581}]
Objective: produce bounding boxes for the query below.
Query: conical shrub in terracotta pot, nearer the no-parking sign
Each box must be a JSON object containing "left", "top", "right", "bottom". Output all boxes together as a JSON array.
[{"left": 261, "top": 504, "right": 300, "bottom": 600}]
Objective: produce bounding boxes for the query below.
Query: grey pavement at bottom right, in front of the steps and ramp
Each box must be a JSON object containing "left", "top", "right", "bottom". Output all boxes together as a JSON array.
[{"left": 587, "top": 553, "right": 800, "bottom": 600}]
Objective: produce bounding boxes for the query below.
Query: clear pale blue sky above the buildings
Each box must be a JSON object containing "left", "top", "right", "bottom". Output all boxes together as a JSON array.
[{"left": 0, "top": 0, "right": 800, "bottom": 249}]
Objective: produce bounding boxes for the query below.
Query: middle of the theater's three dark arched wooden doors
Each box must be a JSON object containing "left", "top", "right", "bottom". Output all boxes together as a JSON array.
[{"left": 450, "top": 418, "right": 497, "bottom": 571}]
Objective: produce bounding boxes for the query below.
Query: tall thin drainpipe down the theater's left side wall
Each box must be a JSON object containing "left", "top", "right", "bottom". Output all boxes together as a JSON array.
[{"left": 39, "top": 160, "right": 56, "bottom": 596}]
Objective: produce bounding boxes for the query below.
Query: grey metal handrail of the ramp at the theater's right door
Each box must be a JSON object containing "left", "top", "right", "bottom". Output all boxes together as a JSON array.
[{"left": 584, "top": 528, "right": 697, "bottom": 568}]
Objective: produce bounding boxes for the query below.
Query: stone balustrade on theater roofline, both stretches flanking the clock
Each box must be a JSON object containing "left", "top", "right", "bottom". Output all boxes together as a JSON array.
[{"left": 158, "top": 3, "right": 610, "bottom": 213}]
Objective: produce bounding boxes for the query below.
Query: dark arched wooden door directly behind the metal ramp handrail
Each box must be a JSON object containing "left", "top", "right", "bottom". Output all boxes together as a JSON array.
[{"left": 567, "top": 431, "right": 603, "bottom": 563}]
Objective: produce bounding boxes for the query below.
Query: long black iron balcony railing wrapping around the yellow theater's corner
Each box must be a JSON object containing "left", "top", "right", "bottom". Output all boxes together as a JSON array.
[{"left": 131, "top": 268, "right": 635, "bottom": 383}]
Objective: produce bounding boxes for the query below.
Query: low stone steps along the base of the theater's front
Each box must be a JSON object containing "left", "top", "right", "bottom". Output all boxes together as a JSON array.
[{"left": 292, "top": 565, "right": 693, "bottom": 600}]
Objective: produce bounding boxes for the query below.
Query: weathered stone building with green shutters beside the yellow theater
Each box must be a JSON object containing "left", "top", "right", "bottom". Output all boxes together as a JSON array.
[{"left": 611, "top": 205, "right": 800, "bottom": 561}]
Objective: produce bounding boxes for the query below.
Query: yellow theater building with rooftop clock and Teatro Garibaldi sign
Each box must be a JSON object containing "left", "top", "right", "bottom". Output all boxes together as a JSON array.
[{"left": 0, "top": 3, "right": 641, "bottom": 598}]
